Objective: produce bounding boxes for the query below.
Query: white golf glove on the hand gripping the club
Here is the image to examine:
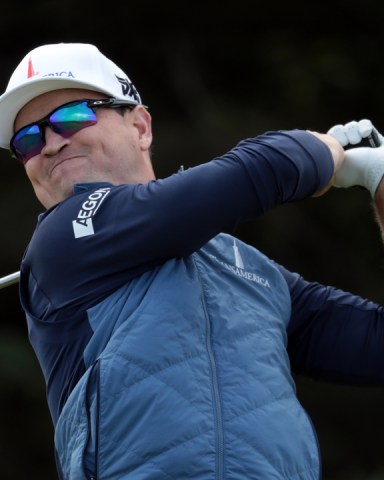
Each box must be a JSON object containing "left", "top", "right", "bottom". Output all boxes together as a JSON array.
[{"left": 328, "top": 119, "right": 384, "bottom": 197}]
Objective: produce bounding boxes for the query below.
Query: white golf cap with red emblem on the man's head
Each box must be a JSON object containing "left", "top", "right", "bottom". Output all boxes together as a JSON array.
[{"left": 0, "top": 43, "right": 141, "bottom": 148}]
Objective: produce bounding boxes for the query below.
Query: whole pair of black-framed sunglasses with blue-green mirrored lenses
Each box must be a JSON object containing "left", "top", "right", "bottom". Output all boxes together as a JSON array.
[{"left": 10, "top": 98, "right": 136, "bottom": 164}]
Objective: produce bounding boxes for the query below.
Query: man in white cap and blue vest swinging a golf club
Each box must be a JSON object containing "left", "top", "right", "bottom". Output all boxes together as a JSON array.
[{"left": 0, "top": 44, "right": 384, "bottom": 480}]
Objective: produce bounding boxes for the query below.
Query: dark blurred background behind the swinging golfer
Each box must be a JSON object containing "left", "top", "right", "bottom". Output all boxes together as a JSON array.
[{"left": 0, "top": 0, "right": 384, "bottom": 480}]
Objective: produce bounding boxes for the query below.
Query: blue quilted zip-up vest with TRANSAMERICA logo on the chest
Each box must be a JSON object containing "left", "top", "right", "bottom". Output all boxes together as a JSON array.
[{"left": 55, "top": 234, "right": 320, "bottom": 480}]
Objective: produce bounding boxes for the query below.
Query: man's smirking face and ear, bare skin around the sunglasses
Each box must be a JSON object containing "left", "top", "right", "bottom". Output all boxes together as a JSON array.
[{"left": 15, "top": 89, "right": 154, "bottom": 208}]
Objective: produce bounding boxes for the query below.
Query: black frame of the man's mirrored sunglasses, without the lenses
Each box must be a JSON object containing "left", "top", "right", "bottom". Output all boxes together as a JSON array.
[{"left": 9, "top": 98, "right": 141, "bottom": 165}]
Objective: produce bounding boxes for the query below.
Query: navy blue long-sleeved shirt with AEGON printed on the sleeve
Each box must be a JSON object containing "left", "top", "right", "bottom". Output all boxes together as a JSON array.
[{"left": 20, "top": 130, "right": 384, "bottom": 422}]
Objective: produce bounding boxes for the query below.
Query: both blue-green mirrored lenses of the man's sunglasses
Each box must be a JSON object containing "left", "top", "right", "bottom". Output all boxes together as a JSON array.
[{"left": 11, "top": 101, "right": 97, "bottom": 164}]
